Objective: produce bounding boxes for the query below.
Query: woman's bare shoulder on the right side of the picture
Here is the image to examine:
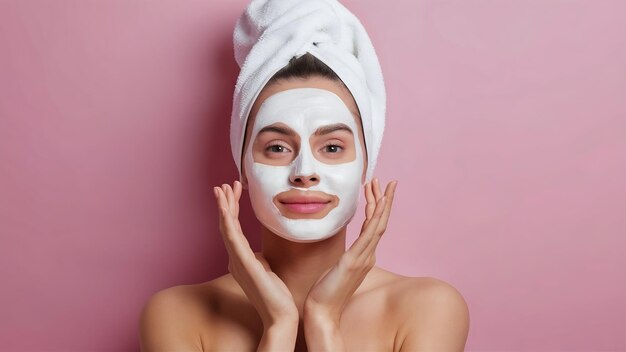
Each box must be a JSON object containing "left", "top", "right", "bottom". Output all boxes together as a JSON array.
[{"left": 370, "top": 272, "right": 469, "bottom": 351}]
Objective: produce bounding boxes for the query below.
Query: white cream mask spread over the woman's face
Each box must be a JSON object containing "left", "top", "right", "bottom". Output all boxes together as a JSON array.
[{"left": 244, "top": 88, "right": 363, "bottom": 242}]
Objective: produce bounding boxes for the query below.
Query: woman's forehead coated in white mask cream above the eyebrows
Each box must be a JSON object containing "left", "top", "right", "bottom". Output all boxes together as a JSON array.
[{"left": 252, "top": 88, "right": 356, "bottom": 135}]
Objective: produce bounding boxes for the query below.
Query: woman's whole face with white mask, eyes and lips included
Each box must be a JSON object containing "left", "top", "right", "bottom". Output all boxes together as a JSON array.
[{"left": 242, "top": 77, "right": 366, "bottom": 242}]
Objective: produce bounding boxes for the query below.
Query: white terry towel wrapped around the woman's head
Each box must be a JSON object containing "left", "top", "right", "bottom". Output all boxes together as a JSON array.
[{"left": 230, "top": 0, "right": 386, "bottom": 182}]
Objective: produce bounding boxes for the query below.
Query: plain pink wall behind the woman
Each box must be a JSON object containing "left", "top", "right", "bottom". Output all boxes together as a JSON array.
[{"left": 0, "top": 0, "right": 626, "bottom": 351}]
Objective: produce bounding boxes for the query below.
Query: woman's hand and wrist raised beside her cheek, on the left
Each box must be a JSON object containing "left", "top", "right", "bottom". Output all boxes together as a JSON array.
[{"left": 213, "top": 181, "right": 299, "bottom": 332}]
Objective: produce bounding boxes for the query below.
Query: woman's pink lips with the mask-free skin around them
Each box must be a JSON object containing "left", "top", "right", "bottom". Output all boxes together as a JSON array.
[{"left": 274, "top": 191, "right": 337, "bottom": 218}]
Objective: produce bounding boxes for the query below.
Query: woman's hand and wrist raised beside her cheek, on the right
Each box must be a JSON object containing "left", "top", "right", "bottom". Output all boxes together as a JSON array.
[{"left": 303, "top": 178, "right": 397, "bottom": 332}]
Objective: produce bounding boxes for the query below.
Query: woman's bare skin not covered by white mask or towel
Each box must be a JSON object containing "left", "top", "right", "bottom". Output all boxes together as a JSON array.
[{"left": 140, "top": 77, "right": 469, "bottom": 352}]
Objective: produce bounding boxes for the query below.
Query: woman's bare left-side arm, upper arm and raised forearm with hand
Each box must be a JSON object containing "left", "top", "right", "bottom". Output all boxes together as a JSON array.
[{"left": 139, "top": 182, "right": 298, "bottom": 352}]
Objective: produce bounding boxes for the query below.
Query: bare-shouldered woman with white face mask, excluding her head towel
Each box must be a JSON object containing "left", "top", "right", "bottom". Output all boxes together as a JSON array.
[{"left": 141, "top": 1, "right": 469, "bottom": 351}]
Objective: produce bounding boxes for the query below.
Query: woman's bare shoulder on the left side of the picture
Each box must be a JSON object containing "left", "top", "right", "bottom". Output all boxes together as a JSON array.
[{"left": 139, "top": 274, "right": 243, "bottom": 352}]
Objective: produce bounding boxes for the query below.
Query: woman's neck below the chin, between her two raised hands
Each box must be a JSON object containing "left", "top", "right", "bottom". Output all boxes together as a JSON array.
[{"left": 262, "top": 226, "right": 346, "bottom": 313}]
